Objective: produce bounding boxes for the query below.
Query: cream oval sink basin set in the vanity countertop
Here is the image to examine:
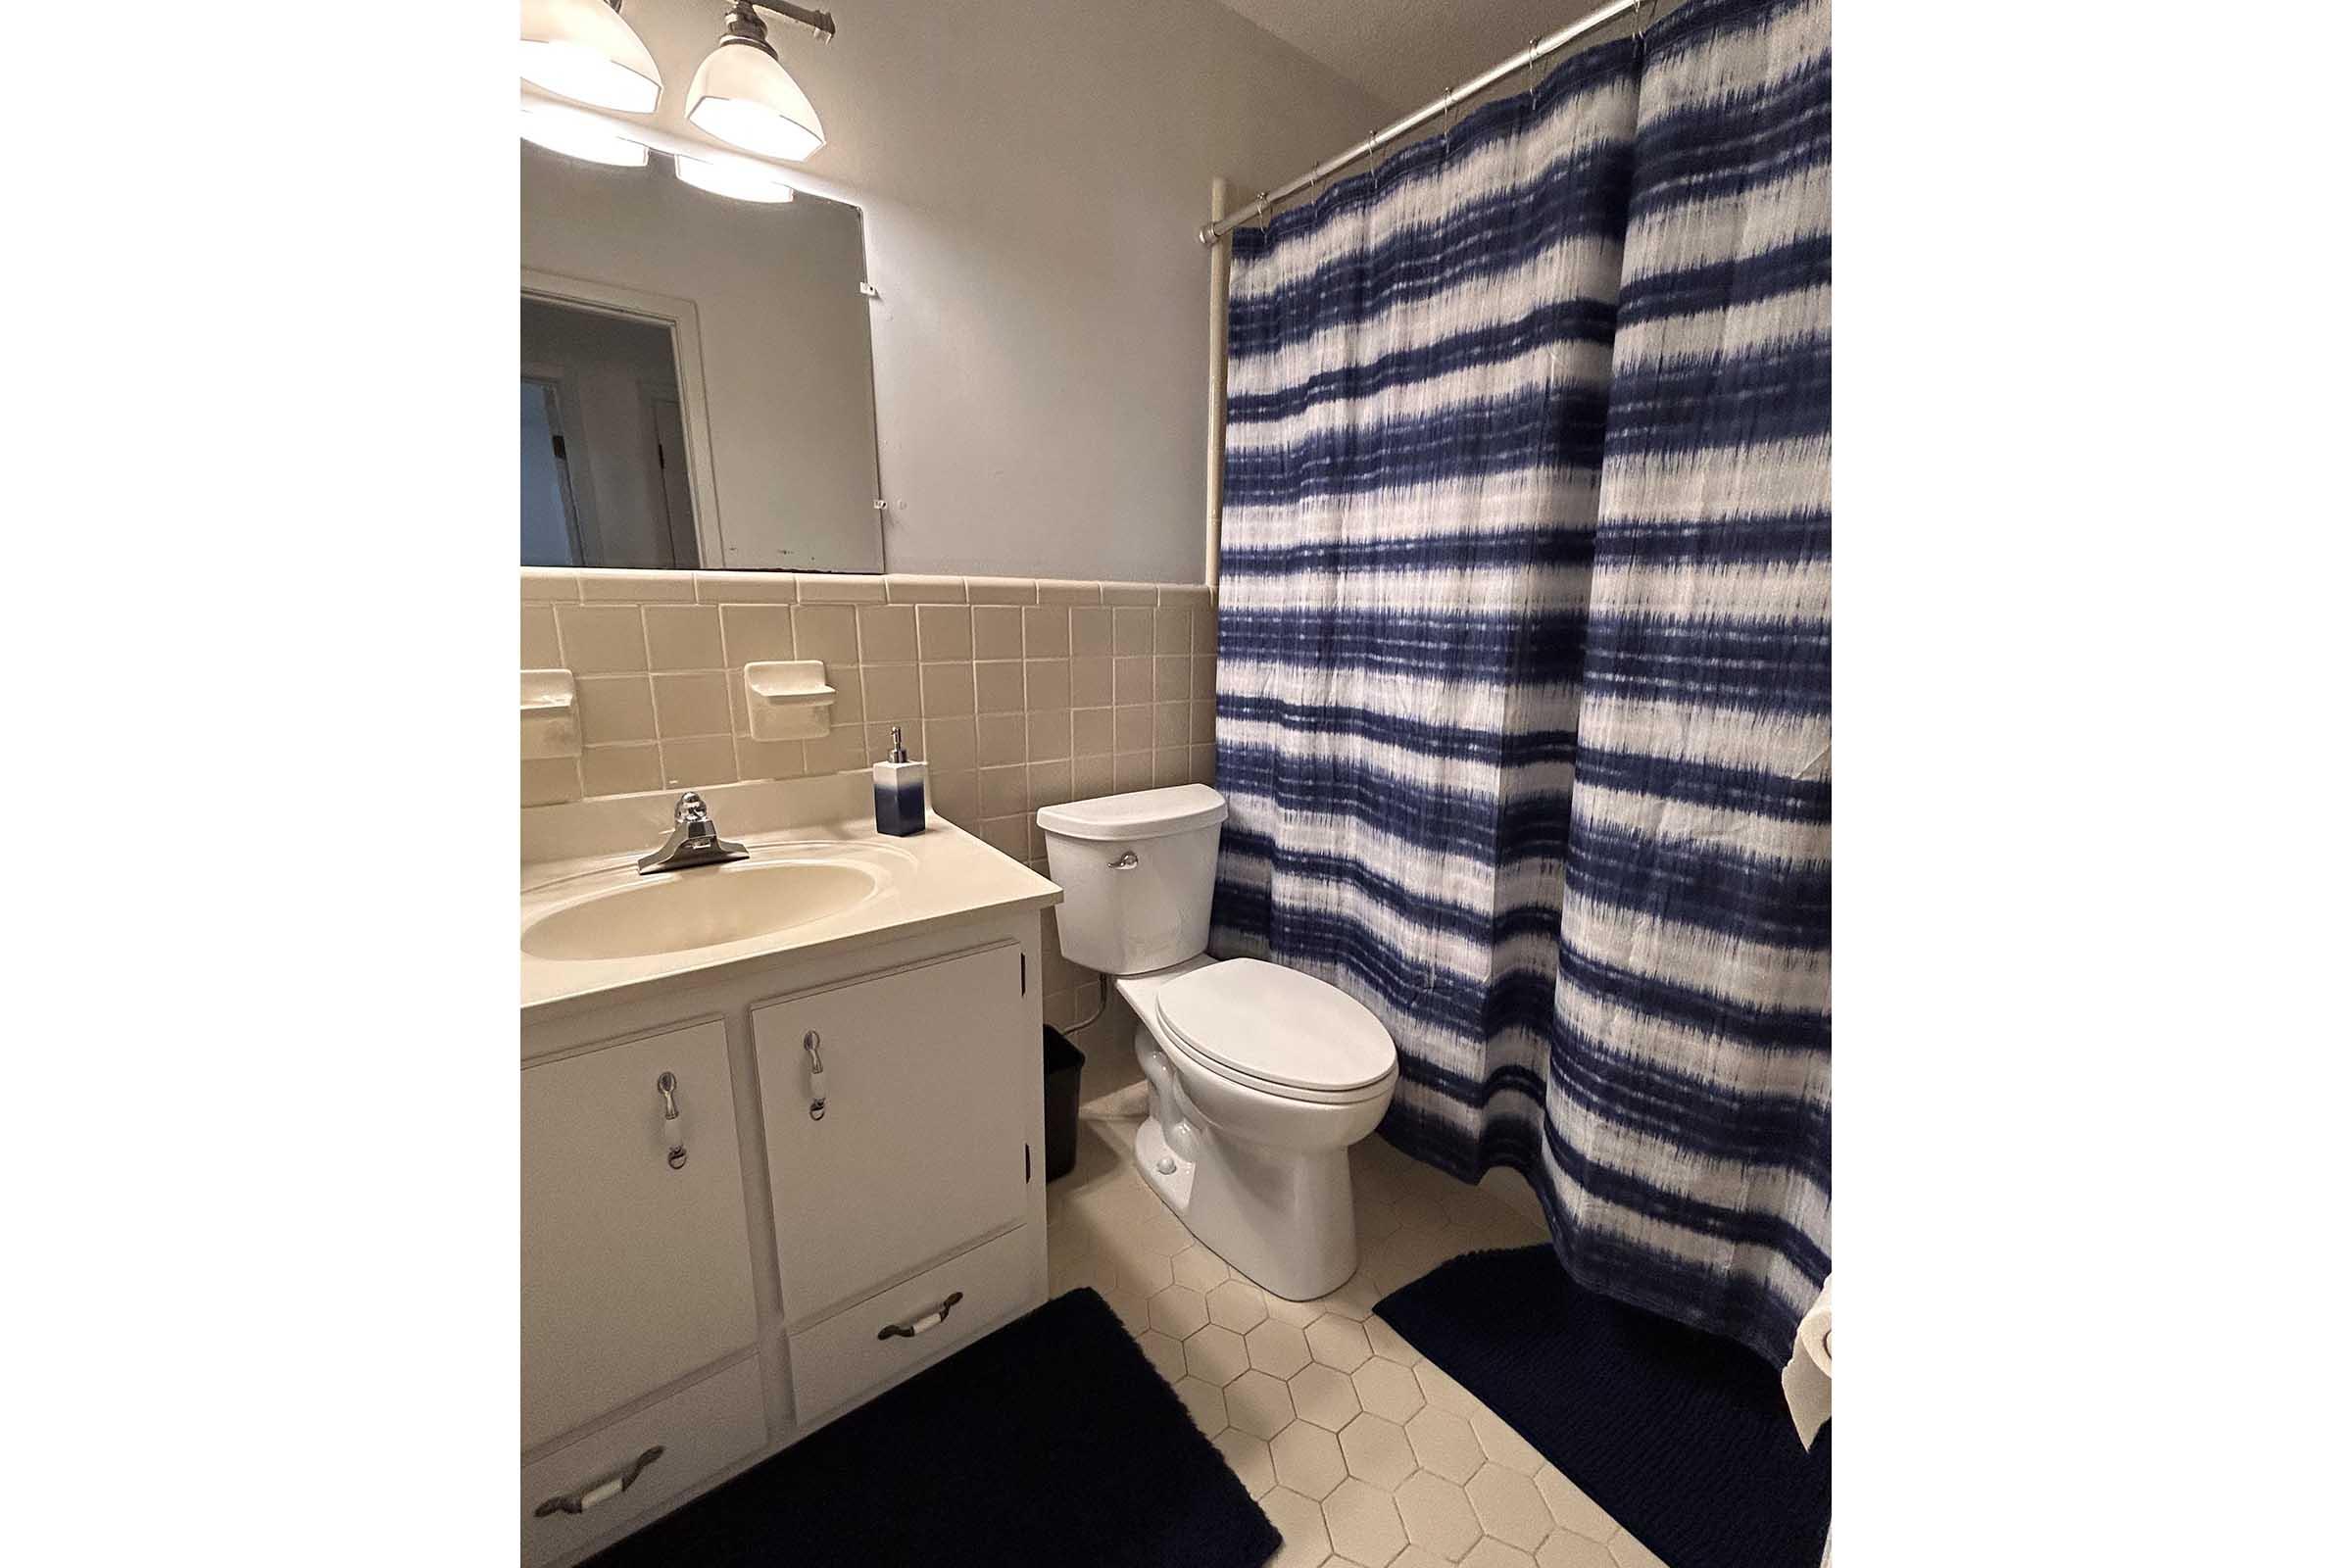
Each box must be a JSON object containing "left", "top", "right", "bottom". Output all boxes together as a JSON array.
[{"left": 522, "top": 860, "right": 882, "bottom": 959}]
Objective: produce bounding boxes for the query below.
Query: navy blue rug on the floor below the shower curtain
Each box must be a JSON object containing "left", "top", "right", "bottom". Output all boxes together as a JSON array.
[{"left": 1378, "top": 1246, "right": 1830, "bottom": 1568}]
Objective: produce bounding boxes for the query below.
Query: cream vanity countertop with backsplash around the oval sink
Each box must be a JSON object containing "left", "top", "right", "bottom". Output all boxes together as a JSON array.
[{"left": 517, "top": 773, "right": 1060, "bottom": 1022}]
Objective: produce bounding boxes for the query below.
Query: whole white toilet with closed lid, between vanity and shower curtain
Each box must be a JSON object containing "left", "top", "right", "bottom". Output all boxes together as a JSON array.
[{"left": 1037, "top": 785, "right": 1397, "bottom": 1300}]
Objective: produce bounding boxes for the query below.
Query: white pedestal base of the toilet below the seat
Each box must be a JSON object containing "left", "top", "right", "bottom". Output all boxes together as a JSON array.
[{"left": 1134, "top": 1089, "right": 1354, "bottom": 1302}]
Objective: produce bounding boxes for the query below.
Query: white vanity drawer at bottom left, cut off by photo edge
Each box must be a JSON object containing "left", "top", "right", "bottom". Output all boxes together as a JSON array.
[{"left": 522, "top": 1356, "right": 766, "bottom": 1566}]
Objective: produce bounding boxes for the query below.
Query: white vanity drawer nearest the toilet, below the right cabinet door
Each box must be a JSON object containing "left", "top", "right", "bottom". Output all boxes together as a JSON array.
[{"left": 786, "top": 1225, "right": 1037, "bottom": 1427}]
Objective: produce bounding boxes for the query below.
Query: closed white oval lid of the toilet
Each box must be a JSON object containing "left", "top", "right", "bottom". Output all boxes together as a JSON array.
[{"left": 1159, "top": 959, "right": 1397, "bottom": 1091}]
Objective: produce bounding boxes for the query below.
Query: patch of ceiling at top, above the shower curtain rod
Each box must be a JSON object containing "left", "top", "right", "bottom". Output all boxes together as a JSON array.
[{"left": 1218, "top": 0, "right": 1601, "bottom": 113}]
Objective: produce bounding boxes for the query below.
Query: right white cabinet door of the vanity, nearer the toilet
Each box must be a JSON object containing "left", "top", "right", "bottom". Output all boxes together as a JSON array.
[{"left": 751, "top": 945, "right": 1042, "bottom": 1324}]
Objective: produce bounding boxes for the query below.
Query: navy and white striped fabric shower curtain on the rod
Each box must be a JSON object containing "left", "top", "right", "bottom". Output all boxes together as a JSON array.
[{"left": 1211, "top": 0, "right": 1830, "bottom": 1361}]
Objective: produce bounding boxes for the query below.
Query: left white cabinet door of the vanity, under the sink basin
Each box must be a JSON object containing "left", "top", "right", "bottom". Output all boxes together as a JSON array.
[{"left": 522, "top": 1020, "right": 758, "bottom": 1448}]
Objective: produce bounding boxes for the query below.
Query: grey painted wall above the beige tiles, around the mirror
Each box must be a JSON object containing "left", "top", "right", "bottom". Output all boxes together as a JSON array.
[{"left": 541, "top": 0, "right": 1388, "bottom": 583}]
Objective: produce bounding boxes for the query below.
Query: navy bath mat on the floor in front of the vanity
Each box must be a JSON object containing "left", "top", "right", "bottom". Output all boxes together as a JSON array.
[{"left": 593, "top": 1291, "right": 1282, "bottom": 1568}]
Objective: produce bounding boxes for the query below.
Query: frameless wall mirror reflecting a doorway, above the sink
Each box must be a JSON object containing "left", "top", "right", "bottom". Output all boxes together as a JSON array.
[{"left": 519, "top": 143, "right": 882, "bottom": 571}]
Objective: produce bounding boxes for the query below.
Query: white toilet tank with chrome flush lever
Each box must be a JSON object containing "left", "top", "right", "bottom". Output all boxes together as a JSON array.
[{"left": 1037, "top": 785, "right": 1225, "bottom": 976}]
